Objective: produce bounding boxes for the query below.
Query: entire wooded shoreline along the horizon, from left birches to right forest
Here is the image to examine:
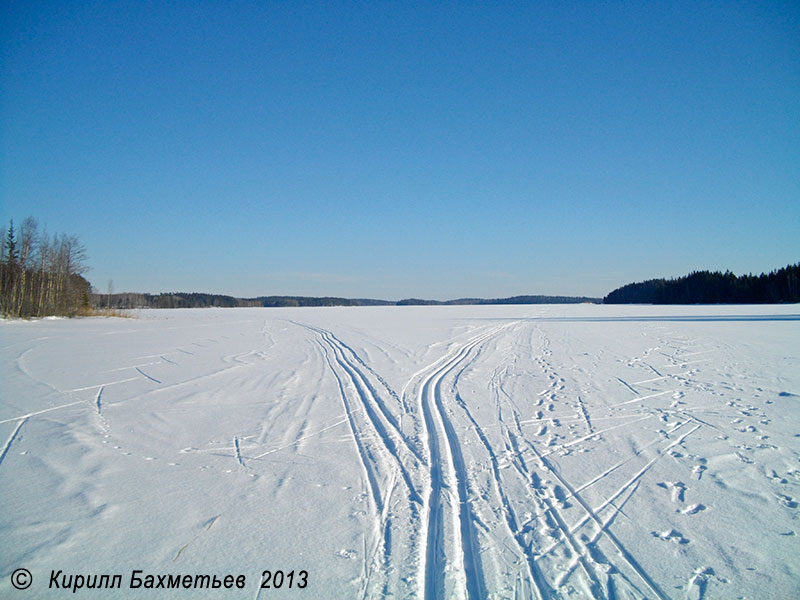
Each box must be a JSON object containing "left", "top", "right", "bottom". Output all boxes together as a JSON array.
[{"left": 6, "top": 217, "right": 800, "bottom": 317}]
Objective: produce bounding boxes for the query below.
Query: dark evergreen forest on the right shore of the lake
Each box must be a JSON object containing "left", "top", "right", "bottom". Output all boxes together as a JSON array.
[{"left": 603, "top": 263, "right": 800, "bottom": 304}]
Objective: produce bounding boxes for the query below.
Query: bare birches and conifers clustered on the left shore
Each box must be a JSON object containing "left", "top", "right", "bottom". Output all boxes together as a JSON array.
[{"left": 0, "top": 217, "right": 91, "bottom": 317}]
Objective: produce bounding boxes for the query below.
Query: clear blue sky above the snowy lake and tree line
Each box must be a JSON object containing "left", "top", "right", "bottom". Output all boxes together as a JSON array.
[{"left": 0, "top": 0, "right": 800, "bottom": 299}]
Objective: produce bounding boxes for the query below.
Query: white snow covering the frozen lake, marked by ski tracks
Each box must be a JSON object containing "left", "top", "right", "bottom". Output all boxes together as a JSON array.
[{"left": 0, "top": 305, "right": 800, "bottom": 599}]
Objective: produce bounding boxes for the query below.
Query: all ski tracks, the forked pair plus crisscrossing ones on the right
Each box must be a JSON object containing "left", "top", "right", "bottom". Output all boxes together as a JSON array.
[{"left": 295, "top": 323, "right": 702, "bottom": 600}]
